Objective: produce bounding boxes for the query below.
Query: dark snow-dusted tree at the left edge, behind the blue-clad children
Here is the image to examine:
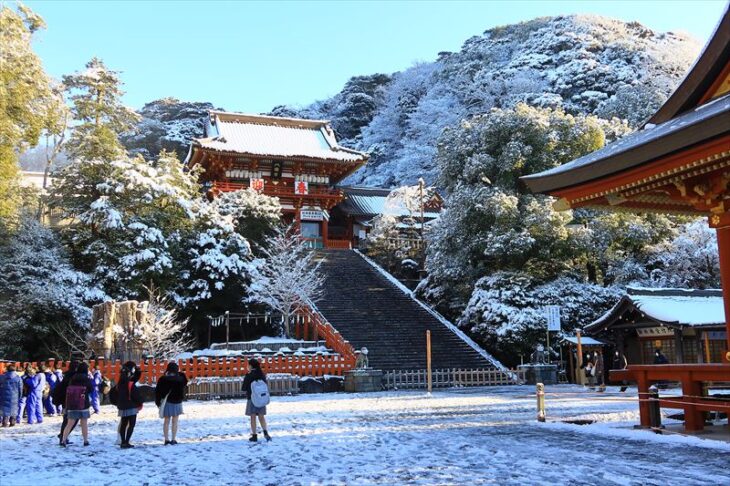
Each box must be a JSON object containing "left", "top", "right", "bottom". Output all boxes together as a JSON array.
[{"left": 0, "top": 215, "right": 105, "bottom": 359}]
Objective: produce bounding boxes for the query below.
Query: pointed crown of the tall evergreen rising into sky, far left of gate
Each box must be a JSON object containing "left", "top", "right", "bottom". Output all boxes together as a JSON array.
[{"left": 63, "top": 57, "right": 139, "bottom": 161}]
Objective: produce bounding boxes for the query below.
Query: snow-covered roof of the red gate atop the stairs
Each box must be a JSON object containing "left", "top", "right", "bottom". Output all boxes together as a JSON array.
[{"left": 193, "top": 111, "right": 368, "bottom": 162}]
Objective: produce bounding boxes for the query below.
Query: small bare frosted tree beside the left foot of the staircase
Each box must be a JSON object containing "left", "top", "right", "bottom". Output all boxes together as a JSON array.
[{"left": 246, "top": 228, "right": 324, "bottom": 337}]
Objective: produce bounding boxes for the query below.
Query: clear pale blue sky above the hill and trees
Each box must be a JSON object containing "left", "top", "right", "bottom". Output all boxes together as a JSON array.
[{"left": 26, "top": 0, "right": 726, "bottom": 113}]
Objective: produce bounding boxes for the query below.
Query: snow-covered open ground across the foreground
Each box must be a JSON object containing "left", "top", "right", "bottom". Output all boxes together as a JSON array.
[{"left": 0, "top": 386, "right": 730, "bottom": 486}]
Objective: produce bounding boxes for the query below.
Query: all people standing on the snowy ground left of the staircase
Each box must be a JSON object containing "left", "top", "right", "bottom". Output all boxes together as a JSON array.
[{"left": 0, "top": 359, "right": 271, "bottom": 449}]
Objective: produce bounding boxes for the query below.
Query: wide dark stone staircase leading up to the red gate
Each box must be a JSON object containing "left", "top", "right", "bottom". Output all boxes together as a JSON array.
[{"left": 317, "top": 250, "right": 510, "bottom": 371}]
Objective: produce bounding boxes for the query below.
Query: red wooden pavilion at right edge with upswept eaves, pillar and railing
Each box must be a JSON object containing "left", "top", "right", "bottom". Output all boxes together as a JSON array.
[{"left": 523, "top": 6, "right": 730, "bottom": 430}]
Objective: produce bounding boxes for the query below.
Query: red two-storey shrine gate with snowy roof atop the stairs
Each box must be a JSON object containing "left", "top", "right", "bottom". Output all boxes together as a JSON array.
[{"left": 186, "top": 111, "right": 368, "bottom": 248}]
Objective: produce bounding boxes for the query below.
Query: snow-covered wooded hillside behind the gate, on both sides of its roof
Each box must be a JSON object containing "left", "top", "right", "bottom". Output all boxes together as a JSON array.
[{"left": 125, "top": 15, "right": 700, "bottom": 187}]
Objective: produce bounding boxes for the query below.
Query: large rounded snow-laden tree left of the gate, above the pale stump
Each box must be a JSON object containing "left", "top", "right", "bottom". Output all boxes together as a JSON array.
[{"left": 50, "top": 153, "right": 200, "bottom": 299}]
